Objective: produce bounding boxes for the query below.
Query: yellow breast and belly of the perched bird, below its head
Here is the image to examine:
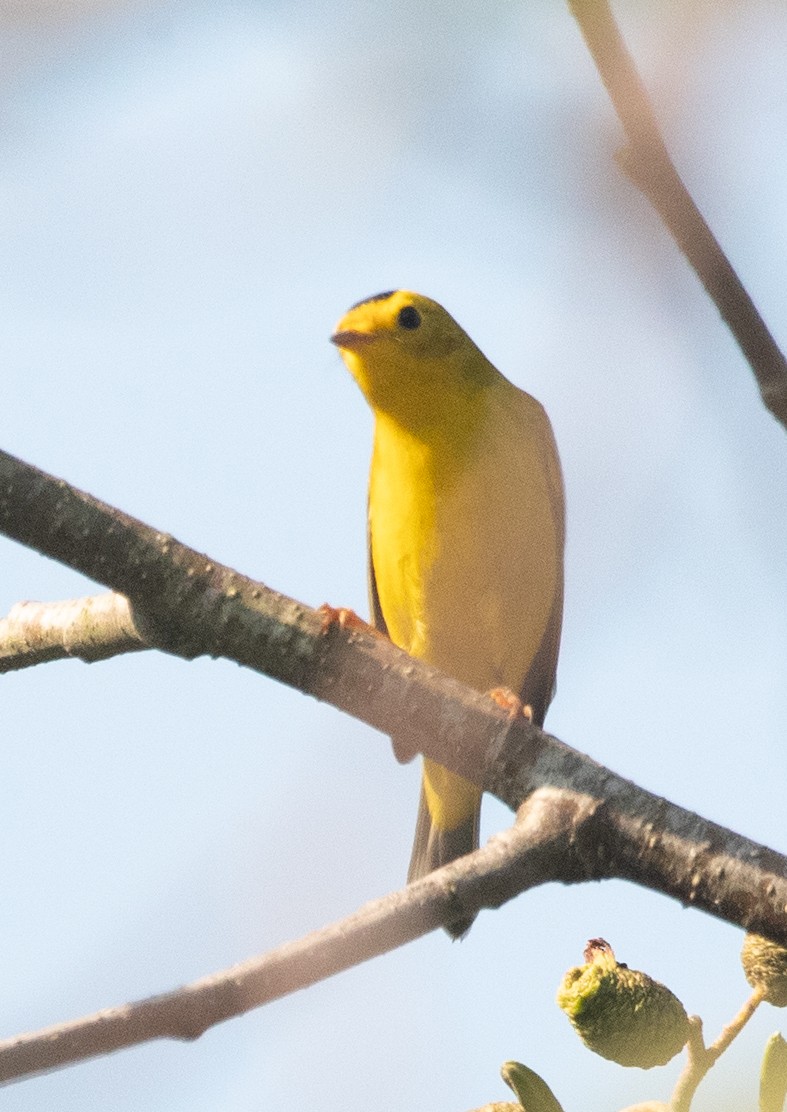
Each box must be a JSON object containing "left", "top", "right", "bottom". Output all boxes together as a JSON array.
[{"left": 369, "top": 380, "right": 562, "bottom": 691}]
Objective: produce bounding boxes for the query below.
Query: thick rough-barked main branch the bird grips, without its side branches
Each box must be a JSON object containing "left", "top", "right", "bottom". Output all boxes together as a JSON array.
[{"left": 0, "top": 453, "right": 787, "bottom": 942}]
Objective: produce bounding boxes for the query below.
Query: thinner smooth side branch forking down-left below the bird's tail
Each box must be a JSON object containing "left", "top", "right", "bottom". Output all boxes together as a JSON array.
[{"left": 0, "top": 792, "right": 586, "bottom": 1083}]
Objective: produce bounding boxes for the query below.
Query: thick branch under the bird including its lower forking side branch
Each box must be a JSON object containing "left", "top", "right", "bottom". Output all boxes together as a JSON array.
[{"left": 0, "top": 444, "right": 787, "bottom": 1079}]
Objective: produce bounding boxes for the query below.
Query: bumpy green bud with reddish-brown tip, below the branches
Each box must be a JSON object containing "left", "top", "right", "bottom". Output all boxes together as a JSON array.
[{"left": 557, "top": 939, "right": 689, "bottom": 1070}]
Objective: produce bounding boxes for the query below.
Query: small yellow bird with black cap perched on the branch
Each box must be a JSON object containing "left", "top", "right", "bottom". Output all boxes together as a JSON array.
[{"left": 331, "top": 289, "right": 565, "bottom": 937}]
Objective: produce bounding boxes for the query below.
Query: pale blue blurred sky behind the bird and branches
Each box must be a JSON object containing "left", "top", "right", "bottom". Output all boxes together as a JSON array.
[{"left": 0, "top": 0, "right": 787, "bottom": 1112}]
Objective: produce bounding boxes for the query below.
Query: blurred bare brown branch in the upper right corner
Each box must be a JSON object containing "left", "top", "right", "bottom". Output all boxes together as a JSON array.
[{"left": 568, "top": 0, "right": 787, "bottom": 428}]
